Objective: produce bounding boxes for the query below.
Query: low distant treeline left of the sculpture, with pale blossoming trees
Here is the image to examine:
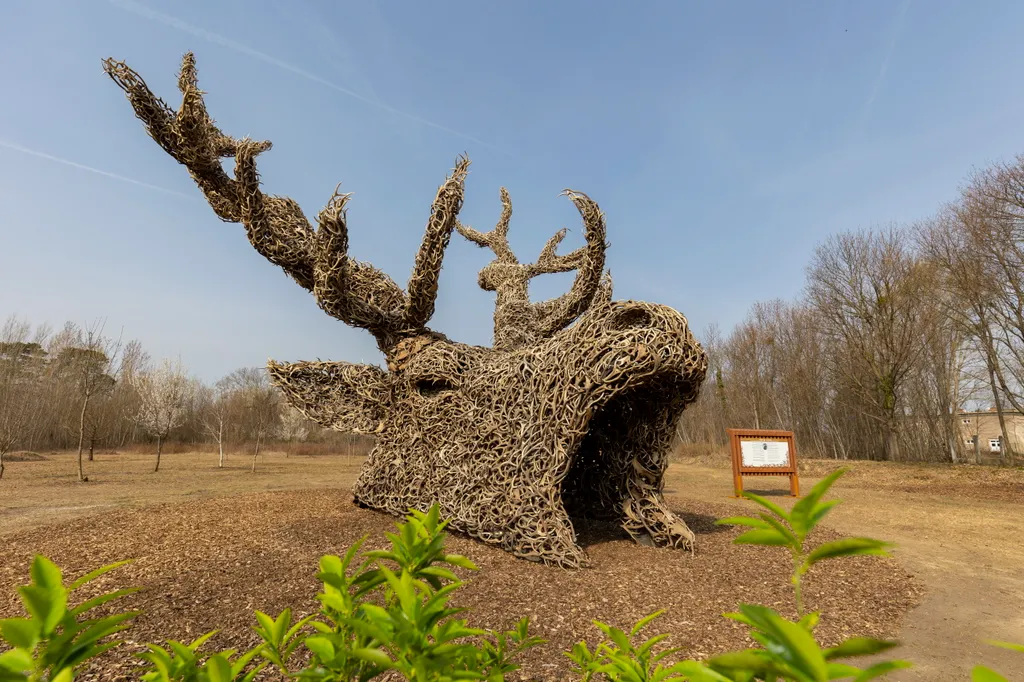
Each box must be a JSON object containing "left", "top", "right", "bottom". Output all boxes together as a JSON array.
[{"left": 0, "top": 316, "right": 370, "bottom": 475}]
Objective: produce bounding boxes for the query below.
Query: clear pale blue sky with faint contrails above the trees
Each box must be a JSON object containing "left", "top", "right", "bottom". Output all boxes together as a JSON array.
[{"left": 0, "top": 0, "right": 1024, "bottom": 380}]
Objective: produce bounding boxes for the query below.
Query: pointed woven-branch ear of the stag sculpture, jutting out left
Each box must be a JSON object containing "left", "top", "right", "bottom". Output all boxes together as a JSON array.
[{"left": 266, "top": 360, "right": 391, "bottom": 433}]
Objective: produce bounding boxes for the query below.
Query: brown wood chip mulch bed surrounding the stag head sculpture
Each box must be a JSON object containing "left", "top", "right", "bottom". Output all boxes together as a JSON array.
[{"left": 0, "top": 489, "right": 922, "bottom": 681}]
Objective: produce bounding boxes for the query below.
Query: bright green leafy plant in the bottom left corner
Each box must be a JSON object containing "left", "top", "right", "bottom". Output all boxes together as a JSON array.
[{"left": 0, "top": 556, "right": 138, "bottom": 682}]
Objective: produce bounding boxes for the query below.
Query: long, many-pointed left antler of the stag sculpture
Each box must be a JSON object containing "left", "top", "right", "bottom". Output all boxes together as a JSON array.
[{"left": 103, "top": 52, "right": 469, "bottom": 351}]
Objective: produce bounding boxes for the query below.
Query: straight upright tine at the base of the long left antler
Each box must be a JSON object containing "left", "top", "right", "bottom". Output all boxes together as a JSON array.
[{"left": 404, "top": 157, "right": 469, "bottom": 328}]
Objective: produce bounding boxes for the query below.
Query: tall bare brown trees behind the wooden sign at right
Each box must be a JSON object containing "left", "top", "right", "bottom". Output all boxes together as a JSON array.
[{"left": 679, "top": 157, "right": 1024, "bottom": 462}]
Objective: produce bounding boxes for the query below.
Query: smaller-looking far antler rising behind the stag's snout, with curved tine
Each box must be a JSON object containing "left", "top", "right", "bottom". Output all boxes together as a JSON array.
[{"left": 456, "top": 187, "right": 611, "bottom": 350}]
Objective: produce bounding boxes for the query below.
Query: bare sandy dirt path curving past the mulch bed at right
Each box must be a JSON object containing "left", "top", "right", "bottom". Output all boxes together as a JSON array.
[{"left": 667, "top": 458, "right": 1024, "bottom": 682}]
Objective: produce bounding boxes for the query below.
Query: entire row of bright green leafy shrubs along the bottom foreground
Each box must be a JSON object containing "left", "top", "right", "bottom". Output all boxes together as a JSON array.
[{"left": 0, "top": 471, "right": 1011, "bottom": 682}]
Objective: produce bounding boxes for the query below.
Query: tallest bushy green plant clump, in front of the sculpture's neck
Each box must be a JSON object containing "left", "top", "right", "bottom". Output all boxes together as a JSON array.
[{"left": 300, "top": 506, "right": 542, "bottom": 680}]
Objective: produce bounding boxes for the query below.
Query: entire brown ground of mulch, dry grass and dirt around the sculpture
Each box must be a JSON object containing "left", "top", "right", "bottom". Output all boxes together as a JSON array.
[{"left": 0, "top": 453, "right": 1024, "bottom": 680}]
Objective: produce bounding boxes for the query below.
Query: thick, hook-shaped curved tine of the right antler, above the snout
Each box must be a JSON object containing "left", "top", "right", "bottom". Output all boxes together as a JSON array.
[{"left": 539, "top": 189, "right": 607, "bottom": 336}]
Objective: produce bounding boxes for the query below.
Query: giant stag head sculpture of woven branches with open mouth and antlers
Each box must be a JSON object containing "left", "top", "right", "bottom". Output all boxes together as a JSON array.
[{"left": 103, "top": 53, "right": 707, "bottom": 567}]
